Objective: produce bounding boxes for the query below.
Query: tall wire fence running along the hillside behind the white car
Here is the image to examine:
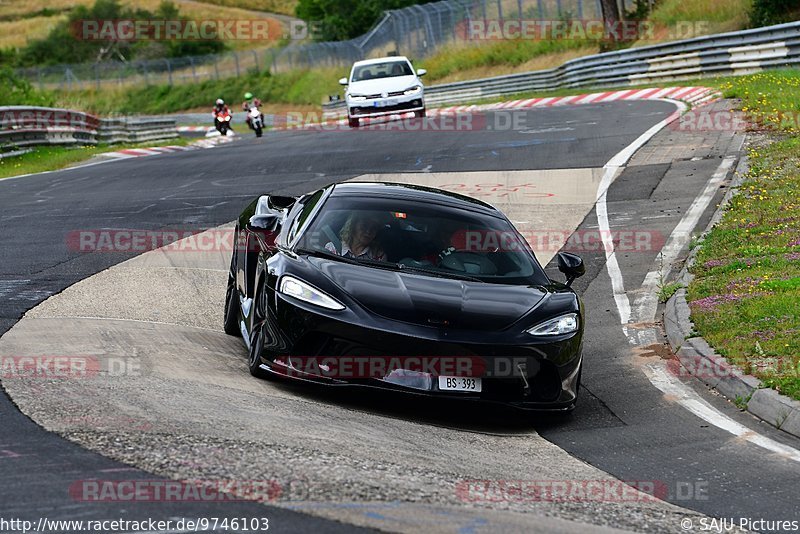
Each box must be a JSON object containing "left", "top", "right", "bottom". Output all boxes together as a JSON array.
[{"left": 18, "top": 0, "right": 635, "bottom": 91}]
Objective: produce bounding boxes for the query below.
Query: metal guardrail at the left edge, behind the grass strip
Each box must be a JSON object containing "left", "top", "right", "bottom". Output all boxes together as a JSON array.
[{"left": 0, "top": 106, "right": 178, "bottom": 155}]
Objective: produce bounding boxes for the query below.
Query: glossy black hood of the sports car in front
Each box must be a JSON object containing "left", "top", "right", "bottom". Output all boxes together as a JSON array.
[{"left": 313, "top": 260, "right": 546, "bottom": 330}]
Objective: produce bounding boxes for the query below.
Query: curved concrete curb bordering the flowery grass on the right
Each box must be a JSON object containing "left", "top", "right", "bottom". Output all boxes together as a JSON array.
[{"left": 664, "top": 155, "right": 800, "bottom": 437}]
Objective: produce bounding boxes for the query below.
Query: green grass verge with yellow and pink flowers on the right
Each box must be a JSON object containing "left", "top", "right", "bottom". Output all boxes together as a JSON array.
[{"left": 688, "top": 71, "right": 800, "bottom": 399}]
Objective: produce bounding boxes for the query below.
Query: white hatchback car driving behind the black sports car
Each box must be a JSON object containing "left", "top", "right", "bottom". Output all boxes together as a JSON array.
[{"left": 339, "top": 56, "right": 427, "bottom": 128}]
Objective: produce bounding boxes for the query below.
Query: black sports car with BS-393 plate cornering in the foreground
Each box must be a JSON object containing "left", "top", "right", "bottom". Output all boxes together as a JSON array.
[{"left": 225, "top": 183, "right": 585, "bottom": 411}]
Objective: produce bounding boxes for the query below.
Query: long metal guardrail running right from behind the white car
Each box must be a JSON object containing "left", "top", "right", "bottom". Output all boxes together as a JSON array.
[{"left": 323, "top": 22, "right": 800, "bottom": 114}]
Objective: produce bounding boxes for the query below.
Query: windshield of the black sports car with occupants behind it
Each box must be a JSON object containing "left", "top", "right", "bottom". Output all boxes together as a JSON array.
[{"left": 295, "top": 196, "right": 547, "bottom": 285}]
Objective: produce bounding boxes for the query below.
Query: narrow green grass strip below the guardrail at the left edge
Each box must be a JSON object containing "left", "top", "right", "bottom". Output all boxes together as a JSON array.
[{"left": 0, "top": 138, "right": 191, "bottom": 179}]
